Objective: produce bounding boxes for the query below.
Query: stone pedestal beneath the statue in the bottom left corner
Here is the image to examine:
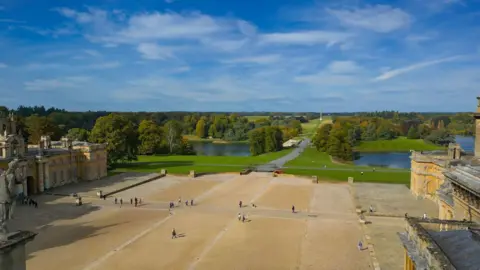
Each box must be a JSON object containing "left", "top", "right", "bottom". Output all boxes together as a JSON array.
[{"left": 0, "top": 231, "right": 36, "bottom": 270}]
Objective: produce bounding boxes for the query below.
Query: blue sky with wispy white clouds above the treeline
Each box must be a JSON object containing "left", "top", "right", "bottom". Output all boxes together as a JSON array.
[{"left": 0, "top": 0, "right": 480, "bottom": 112}]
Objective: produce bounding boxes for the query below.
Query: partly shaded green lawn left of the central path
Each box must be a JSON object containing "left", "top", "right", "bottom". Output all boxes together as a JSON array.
[{"left": 114, "top": 149, "right": 292, "bottom": 174}]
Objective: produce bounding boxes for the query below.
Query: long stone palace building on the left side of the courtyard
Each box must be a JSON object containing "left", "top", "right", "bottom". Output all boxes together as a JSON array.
[{"left": 0, "top": 115, "right": 107, "bottom": 195}]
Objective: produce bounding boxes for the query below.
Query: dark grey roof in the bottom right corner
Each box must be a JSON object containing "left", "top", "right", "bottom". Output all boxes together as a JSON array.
[{"left": 428, "top": 229, "right": 480, "bottom": 270}]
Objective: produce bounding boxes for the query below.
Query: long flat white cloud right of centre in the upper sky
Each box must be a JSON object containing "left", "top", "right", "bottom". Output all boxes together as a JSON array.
[{"left": 260, "top": 31, "right": 352, "bottom": 45}]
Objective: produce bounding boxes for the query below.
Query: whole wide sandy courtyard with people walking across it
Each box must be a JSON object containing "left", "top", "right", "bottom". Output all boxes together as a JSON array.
[{"left": 15, "top": 173, "right": 371, "bottom": 270}]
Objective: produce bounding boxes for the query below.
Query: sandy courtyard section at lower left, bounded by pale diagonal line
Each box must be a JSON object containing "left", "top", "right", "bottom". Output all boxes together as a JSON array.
[{"left": 26, "top": 209, "right": 168, "bottom": 270}]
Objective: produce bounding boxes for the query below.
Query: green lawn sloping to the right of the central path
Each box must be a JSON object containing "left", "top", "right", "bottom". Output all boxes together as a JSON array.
[{"left": 285, "top": 148, "right": 410, "bottom": 184}]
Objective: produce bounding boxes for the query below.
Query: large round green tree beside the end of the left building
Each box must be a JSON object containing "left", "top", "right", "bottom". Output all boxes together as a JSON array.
[{"left": 90, "top": 113, "right": 138, "bottom": 165}]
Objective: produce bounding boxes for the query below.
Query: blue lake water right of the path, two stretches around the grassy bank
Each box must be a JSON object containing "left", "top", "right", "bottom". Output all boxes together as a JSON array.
[{"left": 354, "top": 136, "right": 475, "bottom": 169}]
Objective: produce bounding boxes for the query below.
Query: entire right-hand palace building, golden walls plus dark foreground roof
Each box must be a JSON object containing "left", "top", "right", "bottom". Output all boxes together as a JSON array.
[{"left": 399, "top": 97, "right": 480, "bottom": 270}]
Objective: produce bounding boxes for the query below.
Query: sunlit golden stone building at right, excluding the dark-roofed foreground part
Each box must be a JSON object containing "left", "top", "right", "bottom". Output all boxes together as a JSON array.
[{"left": 410, "top": 98, "right": 480, "bottom": 222}]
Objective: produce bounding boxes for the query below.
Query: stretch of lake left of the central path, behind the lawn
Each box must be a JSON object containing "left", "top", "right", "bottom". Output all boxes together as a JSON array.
[{"left": 191, "top": 142, "right": 250, "bottom": 157}]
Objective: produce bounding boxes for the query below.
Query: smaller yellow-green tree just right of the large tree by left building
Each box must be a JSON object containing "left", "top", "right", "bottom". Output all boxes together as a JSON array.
[{"left": 138, "top": 120, "right": 165, "bottom": 155}]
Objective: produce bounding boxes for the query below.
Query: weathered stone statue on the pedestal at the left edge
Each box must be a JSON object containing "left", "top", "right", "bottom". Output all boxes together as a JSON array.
[{"left": 0, "top": 159, "right": 22, "bottom": 239}]
